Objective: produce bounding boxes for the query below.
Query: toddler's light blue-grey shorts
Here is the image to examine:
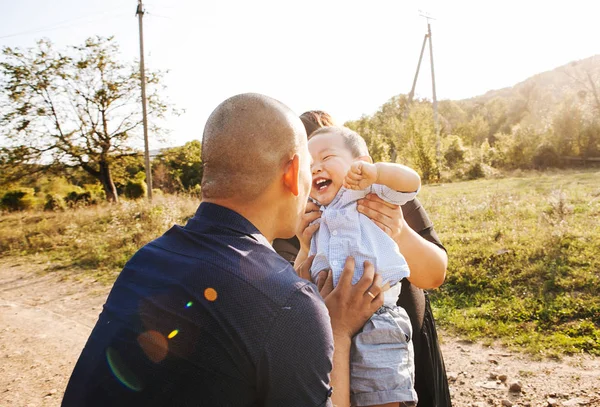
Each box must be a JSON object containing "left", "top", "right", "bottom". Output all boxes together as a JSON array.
[{"left": 350, "top": 305, "right": 417, "bottom": 406}]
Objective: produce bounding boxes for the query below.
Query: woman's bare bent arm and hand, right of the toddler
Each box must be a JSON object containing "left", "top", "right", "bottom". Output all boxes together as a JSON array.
[{"left": 358, "top": 194, "right": 448, "bottom": 289}]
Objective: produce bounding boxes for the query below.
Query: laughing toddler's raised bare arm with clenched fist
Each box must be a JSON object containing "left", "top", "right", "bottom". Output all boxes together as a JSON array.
[{"left": 344, "top": 160, "right": 421, "bottom": 192}]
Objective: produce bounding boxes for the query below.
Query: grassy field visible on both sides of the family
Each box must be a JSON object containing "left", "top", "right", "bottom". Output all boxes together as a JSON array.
[{"left": 0, "top": 171, "right": 600, "bottom": 355}]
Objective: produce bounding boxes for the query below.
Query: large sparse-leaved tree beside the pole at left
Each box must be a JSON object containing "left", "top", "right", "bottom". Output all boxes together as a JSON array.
[{"left": 0, "top": 37, "right": 173, "bottom": 201}]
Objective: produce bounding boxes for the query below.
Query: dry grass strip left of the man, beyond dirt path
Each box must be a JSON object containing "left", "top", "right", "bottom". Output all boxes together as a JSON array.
[{"left": 0, "top": 196, "right": 199, "bottom": 280}]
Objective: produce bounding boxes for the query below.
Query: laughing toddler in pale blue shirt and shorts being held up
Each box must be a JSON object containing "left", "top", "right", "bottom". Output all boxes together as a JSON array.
[{"left": 308, "top": 127, "right": 421, "bottom": 406}]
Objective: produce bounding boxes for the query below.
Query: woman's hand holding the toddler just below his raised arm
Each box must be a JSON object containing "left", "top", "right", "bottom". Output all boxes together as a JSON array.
[{"left": 357, "top": 194, "right": 404, "bottom": 243}]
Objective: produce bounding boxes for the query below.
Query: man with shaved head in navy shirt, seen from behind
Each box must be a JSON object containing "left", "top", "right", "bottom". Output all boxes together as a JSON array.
[{"left": 63, "top": 94, "right": 383, "bottom": 406}]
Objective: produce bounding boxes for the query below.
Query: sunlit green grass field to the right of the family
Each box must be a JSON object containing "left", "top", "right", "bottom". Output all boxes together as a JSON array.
[{"left": 421, "top": 171, "right": 600, "bottom": 355}]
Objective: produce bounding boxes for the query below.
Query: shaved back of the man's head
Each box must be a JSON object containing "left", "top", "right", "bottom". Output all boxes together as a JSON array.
[{"left": 202, "top": 93, "right": 306, "bottom": 202}]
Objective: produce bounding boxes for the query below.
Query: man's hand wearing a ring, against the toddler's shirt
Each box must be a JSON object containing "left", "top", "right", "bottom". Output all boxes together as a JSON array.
[{"left": 324, "top": 257, "right": 384, "bottom": 338}]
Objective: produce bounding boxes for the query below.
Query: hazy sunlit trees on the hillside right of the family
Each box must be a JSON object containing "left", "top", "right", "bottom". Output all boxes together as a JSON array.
[{"left": 345, "top": 56, "right": 600, "bottom": 181}]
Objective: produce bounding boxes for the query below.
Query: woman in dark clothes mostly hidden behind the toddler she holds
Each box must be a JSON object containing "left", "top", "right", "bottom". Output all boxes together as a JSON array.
[{"left": 273, "top": 111, "right": 451, "bottom": 407}]
